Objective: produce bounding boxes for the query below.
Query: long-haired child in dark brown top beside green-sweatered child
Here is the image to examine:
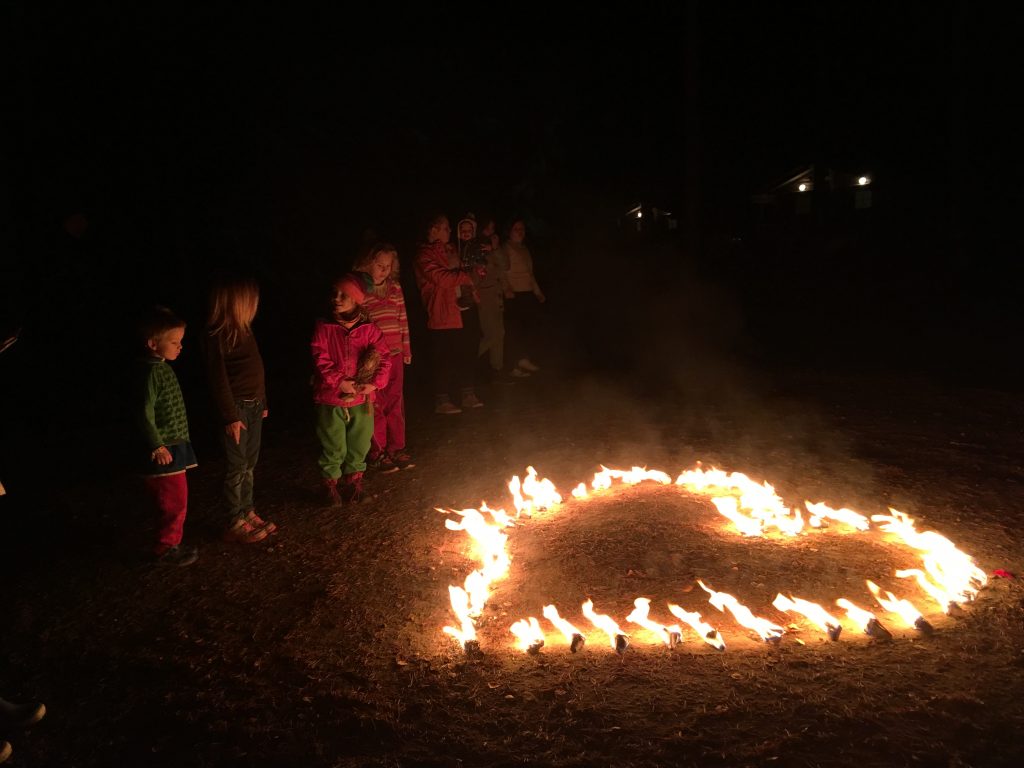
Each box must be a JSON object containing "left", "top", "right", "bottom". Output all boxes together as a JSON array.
[{"left": 206, "top": 279, "right": 278, "bottom": 544}]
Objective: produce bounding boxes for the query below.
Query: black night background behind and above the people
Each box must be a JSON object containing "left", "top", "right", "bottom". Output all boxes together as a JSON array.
[{"left": 0, "top": 2, "right": 1024, "bottom": 487}]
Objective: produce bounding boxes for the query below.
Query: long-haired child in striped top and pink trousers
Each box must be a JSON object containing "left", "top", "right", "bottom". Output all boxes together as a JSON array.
[{"left": 355, "top": 243, "right": 416, "bottom": 473}]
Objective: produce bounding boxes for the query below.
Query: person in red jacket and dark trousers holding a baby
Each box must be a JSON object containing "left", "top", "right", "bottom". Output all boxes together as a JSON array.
[{"left": 416, "top": 216, "right": 483, "bottom": 414}]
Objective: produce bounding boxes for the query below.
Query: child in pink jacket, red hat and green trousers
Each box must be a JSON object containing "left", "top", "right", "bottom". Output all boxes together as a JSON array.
[{"left": 311, "top": 274, "right": 391, "bottom": 507}]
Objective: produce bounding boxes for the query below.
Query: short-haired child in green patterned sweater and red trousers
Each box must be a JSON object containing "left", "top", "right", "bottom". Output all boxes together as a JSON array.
[{"left": 135, "top": 306, "right": 199, "bottom": 565}]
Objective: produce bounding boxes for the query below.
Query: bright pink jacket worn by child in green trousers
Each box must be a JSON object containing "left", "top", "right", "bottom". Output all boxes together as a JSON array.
[{"left": 311, "top": 319, "right": 391, "bottom": 408}]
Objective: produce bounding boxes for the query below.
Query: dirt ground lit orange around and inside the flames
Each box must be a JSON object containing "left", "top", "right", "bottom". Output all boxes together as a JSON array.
[{"left": 0, "top": 373, "right": 1024, "bottom": 768}]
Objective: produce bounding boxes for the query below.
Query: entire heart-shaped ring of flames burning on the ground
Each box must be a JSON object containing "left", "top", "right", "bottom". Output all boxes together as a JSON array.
[{"left": 437, "top": 466, "right": 987, "bottom": 653}]
